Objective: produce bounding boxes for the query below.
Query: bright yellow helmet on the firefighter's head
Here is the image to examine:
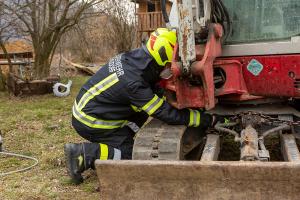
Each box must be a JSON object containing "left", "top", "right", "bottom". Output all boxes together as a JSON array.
[{"left": 146, "top": 28, "right": 177, "bottom": 66}]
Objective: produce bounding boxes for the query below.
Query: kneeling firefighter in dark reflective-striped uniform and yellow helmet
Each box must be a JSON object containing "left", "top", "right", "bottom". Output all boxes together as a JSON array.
[{"left": 64, "top": 28, "right": 218, "bottom": 184}]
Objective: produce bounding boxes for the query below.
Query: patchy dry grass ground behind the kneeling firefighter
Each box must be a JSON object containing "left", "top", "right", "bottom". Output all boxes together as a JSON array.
[{"left": 0, "top": 77, "right": 99, "bottom": 200}]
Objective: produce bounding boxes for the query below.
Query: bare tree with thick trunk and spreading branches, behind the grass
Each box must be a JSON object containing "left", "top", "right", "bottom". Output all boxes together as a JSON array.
[{"left": 1, "top": 0, "right": 106, "bottom": 78}]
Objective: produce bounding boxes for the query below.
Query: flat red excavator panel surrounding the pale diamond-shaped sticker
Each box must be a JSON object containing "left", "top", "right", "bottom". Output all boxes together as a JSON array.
[{"left": 221, "top": 55, "right": 300, "bottom": 97}]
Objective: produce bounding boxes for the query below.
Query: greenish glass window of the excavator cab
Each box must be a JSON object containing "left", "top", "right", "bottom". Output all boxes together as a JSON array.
[{"left": 223, "top": 0, "right": 300, "bottom": 44}]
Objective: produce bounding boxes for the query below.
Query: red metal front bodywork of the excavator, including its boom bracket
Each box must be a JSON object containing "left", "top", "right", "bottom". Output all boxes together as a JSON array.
[{"left": 163, "top": 26, "right": 300, "bottom": 109}]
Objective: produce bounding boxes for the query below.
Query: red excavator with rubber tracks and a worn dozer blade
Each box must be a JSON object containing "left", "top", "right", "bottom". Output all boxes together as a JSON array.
[{"left": 96, "top": 0, "right": 300, "bottom": 199}]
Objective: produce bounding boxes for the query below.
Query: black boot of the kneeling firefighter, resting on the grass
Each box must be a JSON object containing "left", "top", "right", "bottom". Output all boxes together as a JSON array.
[{"left": 64, "top": 144, "right": 86, "bottom": 184}]
